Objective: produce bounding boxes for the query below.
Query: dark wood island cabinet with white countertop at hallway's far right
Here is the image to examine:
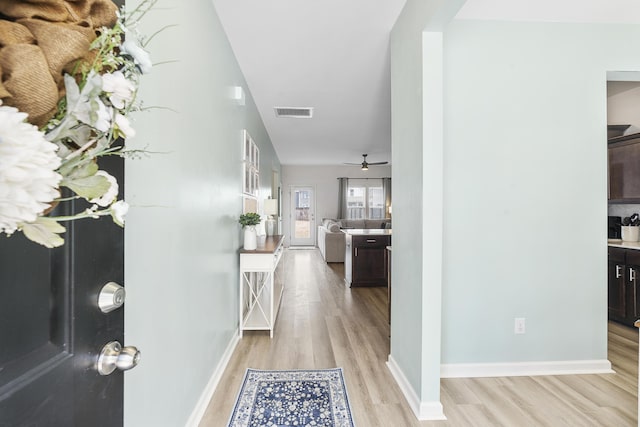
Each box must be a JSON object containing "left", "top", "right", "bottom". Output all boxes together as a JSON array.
[{"left": 344, "top": 230, "right": 391, "bottom": 286}]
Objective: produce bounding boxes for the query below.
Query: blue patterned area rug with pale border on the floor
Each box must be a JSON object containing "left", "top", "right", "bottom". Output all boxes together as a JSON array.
[{"left": 229, "top": 368, "right": 354, "bottom": 427}]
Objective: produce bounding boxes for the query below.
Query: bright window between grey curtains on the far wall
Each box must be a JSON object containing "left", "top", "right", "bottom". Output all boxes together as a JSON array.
[{"left": 347, "top": 179, "right": 384, "bottom": 219}]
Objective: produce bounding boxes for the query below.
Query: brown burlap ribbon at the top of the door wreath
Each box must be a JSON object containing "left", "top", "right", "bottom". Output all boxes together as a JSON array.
[{"left": 0, "top": 0, "right": 117, "bottom": 127}]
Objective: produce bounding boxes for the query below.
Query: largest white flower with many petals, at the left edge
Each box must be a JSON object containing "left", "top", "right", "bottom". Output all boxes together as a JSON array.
[{"left": 0, "top": 106, "right": 62, "bottom": 234}]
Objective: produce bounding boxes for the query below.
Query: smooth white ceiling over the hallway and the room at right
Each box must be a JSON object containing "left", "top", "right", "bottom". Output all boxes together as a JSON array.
[{"left": 213, "top": 0, "right": 640, "bottom": 165}]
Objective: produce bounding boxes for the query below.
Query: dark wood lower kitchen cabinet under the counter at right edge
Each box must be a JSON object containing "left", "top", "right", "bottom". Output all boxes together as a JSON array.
[{"left": 607, "top": 247, "right": 640, "bottom": 326}]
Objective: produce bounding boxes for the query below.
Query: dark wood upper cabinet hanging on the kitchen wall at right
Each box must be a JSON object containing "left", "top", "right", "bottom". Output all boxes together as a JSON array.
[{"left": 607, "top": 134, "right": 640, "bottom": 202}]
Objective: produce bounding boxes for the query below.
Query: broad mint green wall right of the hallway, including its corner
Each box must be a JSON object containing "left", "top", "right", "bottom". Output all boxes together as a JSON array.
[{"left": 391, "top": 0, "right": 640, "bottom": 414}]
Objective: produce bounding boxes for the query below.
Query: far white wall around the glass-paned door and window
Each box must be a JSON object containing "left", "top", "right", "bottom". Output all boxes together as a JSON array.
[{"left": 282, "top": 165, "right": 391, "bottom": 245}]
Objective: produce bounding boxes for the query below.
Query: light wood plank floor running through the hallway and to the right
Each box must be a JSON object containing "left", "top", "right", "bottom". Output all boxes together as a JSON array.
[{"left": 200, "top": 249, "right": 638, "bottom": 427}]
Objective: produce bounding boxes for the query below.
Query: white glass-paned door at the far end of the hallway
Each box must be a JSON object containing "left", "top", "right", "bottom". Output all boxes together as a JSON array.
[{"left": 289, "top": 186, "right": 316, "bottom": 246}]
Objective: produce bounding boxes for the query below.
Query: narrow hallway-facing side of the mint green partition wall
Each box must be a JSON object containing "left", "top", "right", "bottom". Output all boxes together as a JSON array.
[{"left": 390, "top": 5, "right": 424, "bottom": 400}]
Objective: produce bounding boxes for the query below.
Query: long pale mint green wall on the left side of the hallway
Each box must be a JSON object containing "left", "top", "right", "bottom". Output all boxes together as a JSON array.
[{"left": 125, "top": 0, "right": 280, "bottom": 427}]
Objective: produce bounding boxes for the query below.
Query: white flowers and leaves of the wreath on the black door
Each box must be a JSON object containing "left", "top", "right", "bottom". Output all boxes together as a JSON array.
[{"left": 0, "top": 0, "right": 157, "bottom": 248}]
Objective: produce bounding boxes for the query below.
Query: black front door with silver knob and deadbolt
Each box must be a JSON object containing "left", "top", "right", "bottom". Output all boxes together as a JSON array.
[{"left": 0, "top": 152, "right": 124, "bottom": 427}]
